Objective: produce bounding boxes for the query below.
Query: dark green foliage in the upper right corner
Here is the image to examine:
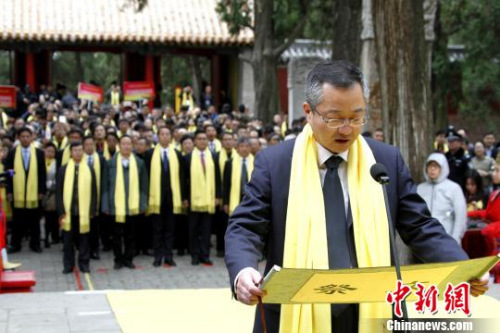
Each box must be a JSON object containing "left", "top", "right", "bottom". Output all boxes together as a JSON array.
[{"left": 433, "top": 0, "right": 500, "bottom": 116}]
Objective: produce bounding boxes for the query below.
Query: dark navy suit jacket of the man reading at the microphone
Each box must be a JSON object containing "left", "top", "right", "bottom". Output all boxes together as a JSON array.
[{"left": 225, "top": 139, "right": 468, "bottom": 327}]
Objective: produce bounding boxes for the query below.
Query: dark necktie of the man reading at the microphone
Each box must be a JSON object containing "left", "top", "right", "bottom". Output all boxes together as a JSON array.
[{"left": 323, "top": 156, "right": 351, "bottom": 317}]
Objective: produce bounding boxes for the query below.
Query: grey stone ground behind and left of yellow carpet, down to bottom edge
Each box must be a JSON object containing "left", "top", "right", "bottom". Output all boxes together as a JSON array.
[{"left": 0, "top": 240, "right": 500, "bottom": 333}]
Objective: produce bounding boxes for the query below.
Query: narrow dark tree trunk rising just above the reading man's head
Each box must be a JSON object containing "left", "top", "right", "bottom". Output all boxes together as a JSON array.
[{"left": 332, "top": 0, "right": 363, "bottom": 66}]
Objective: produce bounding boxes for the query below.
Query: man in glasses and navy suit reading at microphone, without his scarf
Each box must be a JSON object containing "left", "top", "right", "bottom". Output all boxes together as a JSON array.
[{"left": 226, "top": 61, "right": 488, "bottom": 332}]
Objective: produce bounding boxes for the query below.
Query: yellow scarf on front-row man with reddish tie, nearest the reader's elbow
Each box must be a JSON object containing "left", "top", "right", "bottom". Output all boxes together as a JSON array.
[{"left": 190, "top": 148, "right": 215, "bottom": 214}]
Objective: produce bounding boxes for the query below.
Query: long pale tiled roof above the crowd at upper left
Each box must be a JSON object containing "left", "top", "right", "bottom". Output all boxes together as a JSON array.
[{"left": 0, "top": 0, "right": 253, "bottom": 45}]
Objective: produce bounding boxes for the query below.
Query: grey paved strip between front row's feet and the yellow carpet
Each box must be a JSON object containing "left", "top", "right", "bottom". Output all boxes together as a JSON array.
[{"left": 9, "top": 236, "right": 229, "bottom": 292}]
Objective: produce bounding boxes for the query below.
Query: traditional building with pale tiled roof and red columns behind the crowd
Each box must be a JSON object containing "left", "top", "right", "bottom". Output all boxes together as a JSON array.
[{"left": 0, "top": 0, "right": 253, "bottom": 105}]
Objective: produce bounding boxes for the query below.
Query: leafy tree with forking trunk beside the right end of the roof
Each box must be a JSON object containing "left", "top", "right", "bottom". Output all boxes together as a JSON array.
[{"left": 216, "top": 0, "right": 311, "bottom": 121}]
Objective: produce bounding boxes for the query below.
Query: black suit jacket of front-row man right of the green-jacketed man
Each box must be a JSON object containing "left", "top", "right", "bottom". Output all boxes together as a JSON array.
[{"left": 144, "top": 148, "right": 188, "bottom": 211}]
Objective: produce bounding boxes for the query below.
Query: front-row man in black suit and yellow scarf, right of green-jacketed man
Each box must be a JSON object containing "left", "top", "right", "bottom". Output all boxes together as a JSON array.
[{"left": 146, "top": 127, "right": 188, "bottom": 267}]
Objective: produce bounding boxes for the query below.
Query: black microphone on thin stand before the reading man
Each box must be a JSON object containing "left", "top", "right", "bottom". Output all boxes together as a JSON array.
[{"left": 370, "top": 163, "right": 408, "bottom": 320}]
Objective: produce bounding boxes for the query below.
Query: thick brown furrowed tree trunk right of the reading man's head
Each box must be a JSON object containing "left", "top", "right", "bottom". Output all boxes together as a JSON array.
[{"left": 372, "top": 0, "right": 432, "bottom": 182}]
